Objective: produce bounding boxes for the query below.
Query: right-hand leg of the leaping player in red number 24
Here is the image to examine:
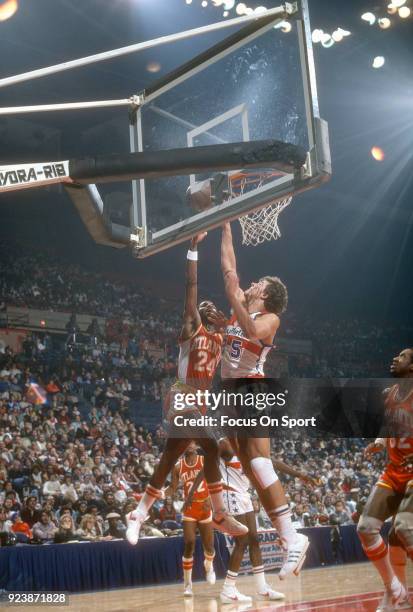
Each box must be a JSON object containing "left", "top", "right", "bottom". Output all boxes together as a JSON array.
[{"left": 197, "top": 437, "right": 247, "bottom": 537}]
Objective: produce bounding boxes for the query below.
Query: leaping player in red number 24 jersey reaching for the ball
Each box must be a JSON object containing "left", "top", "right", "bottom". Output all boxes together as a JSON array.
[{"left": 126, "top": 234, "right": 248, "bottom": 545}]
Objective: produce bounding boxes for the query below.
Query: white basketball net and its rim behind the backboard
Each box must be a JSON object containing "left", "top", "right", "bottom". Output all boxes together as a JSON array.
[{"left": 229, "top": 170, "right": 292, "bottom": 246}]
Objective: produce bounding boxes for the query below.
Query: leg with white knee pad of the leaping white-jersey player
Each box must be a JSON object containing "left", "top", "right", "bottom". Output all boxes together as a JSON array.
[{"left": 238, "top": 438, "right": 309, "bottom": 580}]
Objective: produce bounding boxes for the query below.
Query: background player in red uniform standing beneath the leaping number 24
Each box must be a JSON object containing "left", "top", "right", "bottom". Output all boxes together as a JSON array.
[{"left": 168, "top": 442, "right": 215, "bottom": 597}]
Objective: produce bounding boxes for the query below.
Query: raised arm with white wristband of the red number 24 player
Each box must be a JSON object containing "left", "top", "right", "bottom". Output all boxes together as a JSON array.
[{"left": 180, "top": 232, "right": 206, "bottom": 340}]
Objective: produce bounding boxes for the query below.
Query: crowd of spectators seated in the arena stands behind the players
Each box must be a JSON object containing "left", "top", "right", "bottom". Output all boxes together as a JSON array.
[{"left": 0, "top": 243, "right": 403, "bottom": 543}]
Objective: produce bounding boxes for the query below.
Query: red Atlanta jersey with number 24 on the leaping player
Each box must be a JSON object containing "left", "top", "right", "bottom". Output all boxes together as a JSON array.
[{"left": 178, "top": 325, "right": 223, "bottom": 390}]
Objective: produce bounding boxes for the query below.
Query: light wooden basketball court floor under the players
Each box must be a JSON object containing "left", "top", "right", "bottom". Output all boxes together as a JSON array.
[{"left": 25, "top": 563, "right": 413, "bottom": 612}]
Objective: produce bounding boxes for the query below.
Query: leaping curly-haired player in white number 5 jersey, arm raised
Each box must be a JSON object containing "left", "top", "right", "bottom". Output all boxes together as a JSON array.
[{"left": 221, "top": 223, "right": 309, "bottom": 580}]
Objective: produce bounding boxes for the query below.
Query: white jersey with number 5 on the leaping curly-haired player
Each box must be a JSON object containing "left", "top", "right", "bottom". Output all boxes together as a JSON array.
[{"left": 221, "top": 312, "right": 274, "bottom": 378}]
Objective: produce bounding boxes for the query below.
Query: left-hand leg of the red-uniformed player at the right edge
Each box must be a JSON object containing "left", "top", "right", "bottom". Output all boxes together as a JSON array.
[{"left": 357, "top": 485, "right": 406, "bottom": 612}]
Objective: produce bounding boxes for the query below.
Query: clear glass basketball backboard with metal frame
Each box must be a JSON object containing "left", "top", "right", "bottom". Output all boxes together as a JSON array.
[{"left": 130, "top": 0, "right": 331, "bottom": 257}]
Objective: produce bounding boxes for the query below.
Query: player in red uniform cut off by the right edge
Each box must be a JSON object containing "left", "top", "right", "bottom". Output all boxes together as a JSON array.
[{"left": 357, "top": 348, "right": 413, "bottom": 612}]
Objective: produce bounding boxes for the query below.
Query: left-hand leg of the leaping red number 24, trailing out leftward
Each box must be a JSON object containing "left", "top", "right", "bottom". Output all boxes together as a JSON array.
[{"left": 126, "top": 438, "right": 190, "bottom": 545}]
